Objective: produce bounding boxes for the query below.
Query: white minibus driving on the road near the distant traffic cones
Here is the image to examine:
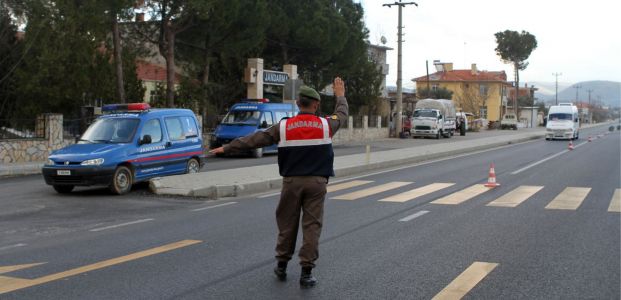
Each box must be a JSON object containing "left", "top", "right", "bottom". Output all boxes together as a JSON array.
[{"left": 546, "top": 103, "right": 580, "bottom": 140}]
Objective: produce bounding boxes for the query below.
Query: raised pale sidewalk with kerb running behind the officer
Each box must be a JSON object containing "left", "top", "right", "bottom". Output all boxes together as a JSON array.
[{"left": 150, "top": 129, "right": 545, "bottom": 199}]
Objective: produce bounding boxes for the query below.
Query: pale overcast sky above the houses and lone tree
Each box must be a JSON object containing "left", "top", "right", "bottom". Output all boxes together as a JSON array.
[{"left": 354, "top": 0, "right": 621, "bottom": 87}]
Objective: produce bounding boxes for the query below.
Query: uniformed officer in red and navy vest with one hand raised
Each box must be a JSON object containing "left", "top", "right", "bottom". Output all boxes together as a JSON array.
[{"left": 210, "top": 77, "right": 348, "bottom": 287}]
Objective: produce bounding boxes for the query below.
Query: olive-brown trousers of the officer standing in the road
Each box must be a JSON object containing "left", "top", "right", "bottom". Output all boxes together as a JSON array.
[{"left": 276, "top": 176, "right": 328, "bottom": 267}]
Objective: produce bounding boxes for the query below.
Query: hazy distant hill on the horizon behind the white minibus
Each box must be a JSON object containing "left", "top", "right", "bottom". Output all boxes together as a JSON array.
[{"left": 528, "top": 81, "right": 621, "bottom": 107}]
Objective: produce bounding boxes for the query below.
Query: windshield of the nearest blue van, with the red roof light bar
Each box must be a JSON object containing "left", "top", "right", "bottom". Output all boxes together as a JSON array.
[{"left": 80, "top": 118, "right": 140, "bottom": 143}]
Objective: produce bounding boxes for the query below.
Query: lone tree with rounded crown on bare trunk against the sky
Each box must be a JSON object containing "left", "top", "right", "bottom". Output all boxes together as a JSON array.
[{"left": 495, "top": 30, "right": 537, "bottom": 118}]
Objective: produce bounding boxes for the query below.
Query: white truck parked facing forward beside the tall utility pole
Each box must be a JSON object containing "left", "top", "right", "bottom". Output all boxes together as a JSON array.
[{"left": 412, "top": 99, "right": 457, "bottom": 139}]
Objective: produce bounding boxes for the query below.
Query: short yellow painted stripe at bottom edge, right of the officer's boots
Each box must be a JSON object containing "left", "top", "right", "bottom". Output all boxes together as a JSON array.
[{"left": 432, "top": 261, "right": 498, "bottom": 300}]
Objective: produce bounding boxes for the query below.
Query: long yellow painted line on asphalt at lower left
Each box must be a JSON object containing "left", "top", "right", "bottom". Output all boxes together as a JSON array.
[{"left": 0, "top": 240, "right": 202, "bottom": 294}]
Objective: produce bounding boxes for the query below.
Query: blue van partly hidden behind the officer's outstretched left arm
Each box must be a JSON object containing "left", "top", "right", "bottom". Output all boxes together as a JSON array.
[{"left": 210, "top": 99, "right": 300, "bottom": 158}]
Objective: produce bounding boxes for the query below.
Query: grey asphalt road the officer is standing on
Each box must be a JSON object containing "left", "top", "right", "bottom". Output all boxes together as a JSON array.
[{"left": 0, "top": 127, "right": 621, "bottom": 299}]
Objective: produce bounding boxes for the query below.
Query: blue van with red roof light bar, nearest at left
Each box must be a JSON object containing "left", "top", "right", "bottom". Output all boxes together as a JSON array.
[{"left": 42, "top": 103, "right": 205, "bottom": 194}]
